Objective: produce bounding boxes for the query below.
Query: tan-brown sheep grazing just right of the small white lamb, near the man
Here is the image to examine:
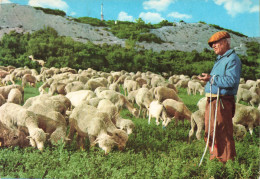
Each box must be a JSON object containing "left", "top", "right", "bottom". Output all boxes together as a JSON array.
[{"left": 162, "top": 99, "right": 192, "bottom": 125}]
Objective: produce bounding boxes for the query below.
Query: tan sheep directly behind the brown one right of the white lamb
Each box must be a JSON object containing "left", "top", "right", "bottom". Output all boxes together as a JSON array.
[{"left": 154, "top": 86, "right": 182, "bottom": 102}]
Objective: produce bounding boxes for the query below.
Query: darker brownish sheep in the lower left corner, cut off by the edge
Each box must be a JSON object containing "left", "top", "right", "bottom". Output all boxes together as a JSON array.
[{"left": 0, "top": 122, "right": 29, "bottom": 147}]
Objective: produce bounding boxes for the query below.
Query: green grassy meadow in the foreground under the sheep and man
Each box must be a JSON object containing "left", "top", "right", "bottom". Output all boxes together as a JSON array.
[{"left": 0, "top": 85, "right": 259, "bottom": 179}]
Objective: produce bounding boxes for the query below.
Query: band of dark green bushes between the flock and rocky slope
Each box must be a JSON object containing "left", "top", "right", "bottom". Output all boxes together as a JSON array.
[{"left": 0, "top": 27, "right": 260, "bottom": 80}]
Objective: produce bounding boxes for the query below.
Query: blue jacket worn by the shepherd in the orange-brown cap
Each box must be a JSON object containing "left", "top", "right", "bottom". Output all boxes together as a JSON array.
[{"left": 205, "top": 49, "right": 241, "bottom": 95}]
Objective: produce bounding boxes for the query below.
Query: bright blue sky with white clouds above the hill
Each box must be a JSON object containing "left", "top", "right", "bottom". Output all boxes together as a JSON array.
[{"left": 0, "top": 0, "right": 260, "bottom": 37}]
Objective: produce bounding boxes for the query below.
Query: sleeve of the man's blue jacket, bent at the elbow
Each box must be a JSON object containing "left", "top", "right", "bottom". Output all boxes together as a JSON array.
[{"left": 213, "top": 58, "right": 241, "bottom": 88}]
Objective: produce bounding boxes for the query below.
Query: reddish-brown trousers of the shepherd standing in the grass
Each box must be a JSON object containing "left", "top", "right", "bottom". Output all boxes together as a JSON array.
[{"left": 204, "top": 96, "right": 236, "bottom": 163}]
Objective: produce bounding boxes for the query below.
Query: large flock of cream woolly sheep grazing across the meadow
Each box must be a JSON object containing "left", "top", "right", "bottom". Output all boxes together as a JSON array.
[{"left": 0, "top": 66, "right": 260, "bottom": 154}]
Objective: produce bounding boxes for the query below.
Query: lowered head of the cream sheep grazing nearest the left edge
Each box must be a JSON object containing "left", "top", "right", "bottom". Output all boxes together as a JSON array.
[{"left": 27, "top": 128, "right": 47, "bottom": 151}]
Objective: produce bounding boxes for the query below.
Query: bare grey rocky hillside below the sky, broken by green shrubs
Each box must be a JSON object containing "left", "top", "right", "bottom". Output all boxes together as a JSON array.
[{"left": 0, "top": 4, "right": 260, "bottom": 54}]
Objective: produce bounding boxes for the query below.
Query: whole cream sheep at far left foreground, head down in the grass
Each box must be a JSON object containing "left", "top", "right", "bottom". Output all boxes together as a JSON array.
[{"left": 0, "top": 103, "right": 46, "bottom": 151}]
